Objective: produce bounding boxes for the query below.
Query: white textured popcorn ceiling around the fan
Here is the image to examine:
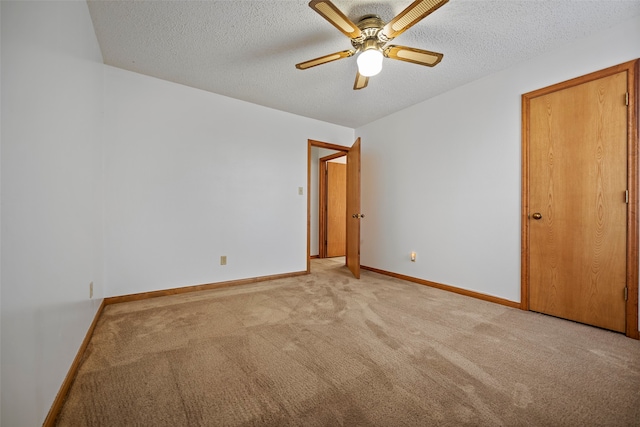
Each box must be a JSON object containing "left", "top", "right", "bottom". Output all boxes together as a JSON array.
[{"left": 88, "top": 0, "right": 640, "bottom": 128}]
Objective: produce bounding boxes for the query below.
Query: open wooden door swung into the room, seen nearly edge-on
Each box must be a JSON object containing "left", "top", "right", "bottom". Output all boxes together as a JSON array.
[{"left": 347, "top": 138, "right": 362, "bottom": 279}]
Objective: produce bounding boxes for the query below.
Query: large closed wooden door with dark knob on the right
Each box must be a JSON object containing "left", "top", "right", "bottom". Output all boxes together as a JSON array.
[{"left": 527, "top": 72, "right": 628, "bottom": 332}]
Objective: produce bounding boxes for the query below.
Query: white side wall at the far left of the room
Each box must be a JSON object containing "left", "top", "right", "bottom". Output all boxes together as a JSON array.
[{"left": 0, "top": 1, "right": 103, "bottom": 426}]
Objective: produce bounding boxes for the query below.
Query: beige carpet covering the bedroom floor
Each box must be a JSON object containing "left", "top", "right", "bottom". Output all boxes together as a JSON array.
[{"left": 58, "top": 260, "right": 640, "bottom": 426}]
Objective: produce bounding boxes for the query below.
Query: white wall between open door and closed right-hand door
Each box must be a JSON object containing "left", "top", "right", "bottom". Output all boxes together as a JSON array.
[{"left": 356, "top": 17, "right": 640, "bottom": 302}]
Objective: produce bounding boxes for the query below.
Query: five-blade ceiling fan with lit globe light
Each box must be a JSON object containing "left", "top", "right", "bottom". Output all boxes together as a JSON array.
[{"left": 296, "top": 0, "right": 449, "bottom": 90}]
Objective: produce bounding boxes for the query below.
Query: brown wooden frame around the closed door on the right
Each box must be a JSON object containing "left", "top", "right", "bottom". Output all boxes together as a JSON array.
[{"left": 520, "top": 59, "right": 640, "bottom": 339}]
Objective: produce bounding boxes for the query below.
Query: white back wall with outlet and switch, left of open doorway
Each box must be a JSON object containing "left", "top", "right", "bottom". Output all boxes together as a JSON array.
[{"left": 105, "top": 67, "right": 354, "bottom": 295}]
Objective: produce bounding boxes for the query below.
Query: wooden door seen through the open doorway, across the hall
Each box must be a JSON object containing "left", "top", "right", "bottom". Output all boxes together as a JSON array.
[{"left": 326, "top": 162, "right": 347, "bottom": 257}]
